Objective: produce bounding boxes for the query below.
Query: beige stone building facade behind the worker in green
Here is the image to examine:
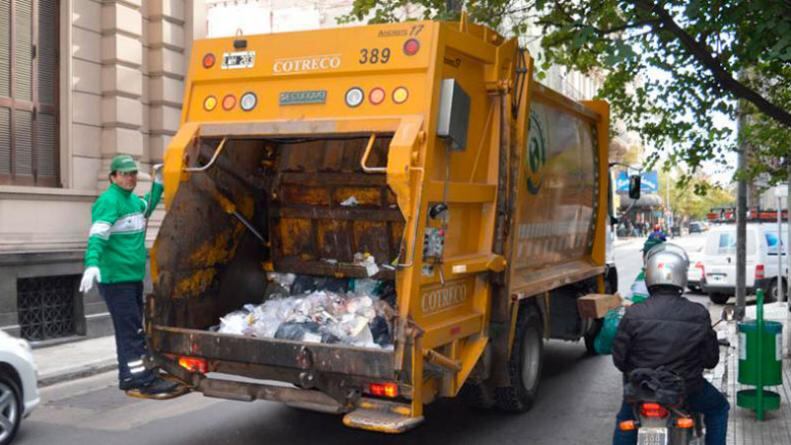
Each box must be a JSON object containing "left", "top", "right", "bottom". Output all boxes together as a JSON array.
[{"left": 0, "top": 0, "right": 206, "bottom": 343}]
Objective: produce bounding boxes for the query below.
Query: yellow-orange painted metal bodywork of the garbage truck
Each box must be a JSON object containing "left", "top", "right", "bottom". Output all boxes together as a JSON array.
[{"left": 162, "top": 17, "right": 609, "bottom": 432}]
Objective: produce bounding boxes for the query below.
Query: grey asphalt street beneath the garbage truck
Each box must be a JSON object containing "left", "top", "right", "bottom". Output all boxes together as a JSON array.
[{"left": 15, "top": 237, "right": 707, "bottom": 445}]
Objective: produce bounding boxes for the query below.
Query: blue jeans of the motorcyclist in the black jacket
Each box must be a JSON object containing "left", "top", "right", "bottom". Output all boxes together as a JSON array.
[{"left": 612, "top": 381, "right": 731, "bottom": 445}]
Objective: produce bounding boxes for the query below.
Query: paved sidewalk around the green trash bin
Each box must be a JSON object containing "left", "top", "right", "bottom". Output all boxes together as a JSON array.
[{"left": 713, "top": 303, "right": 791, "bottom": 445}]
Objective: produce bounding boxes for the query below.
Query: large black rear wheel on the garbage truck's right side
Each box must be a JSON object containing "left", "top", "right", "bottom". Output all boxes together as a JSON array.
[{"left": 494, "top": 306, "right": 544, "bottom": 413}]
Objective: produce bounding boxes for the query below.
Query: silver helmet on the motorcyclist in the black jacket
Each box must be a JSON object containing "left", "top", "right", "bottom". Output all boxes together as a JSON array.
[{"left": 645, "top": 243, "right": 689, "bottom": 292}]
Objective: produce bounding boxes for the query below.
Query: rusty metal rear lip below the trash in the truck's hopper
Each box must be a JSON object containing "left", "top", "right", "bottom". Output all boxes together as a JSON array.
[{"left": 151, "top": 326, "right": 394, "bottom": 378}]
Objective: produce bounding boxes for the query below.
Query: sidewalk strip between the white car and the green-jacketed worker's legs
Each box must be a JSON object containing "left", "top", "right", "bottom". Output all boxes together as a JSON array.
[{"left": 33, "top": 336, "right": 118, "bottom": 387}]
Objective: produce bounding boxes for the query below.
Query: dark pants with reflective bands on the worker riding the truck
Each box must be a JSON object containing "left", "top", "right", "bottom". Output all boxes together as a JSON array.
[{"left": 99, "top": 281, "right": 154, "bottom": 389}]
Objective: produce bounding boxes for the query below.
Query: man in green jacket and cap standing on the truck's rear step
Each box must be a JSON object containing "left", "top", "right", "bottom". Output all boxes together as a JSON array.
[{"left": 80, "top": 155, "right": 183, "bottom": 398}]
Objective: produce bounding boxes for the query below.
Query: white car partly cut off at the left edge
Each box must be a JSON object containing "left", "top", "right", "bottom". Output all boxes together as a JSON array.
[{"left": 0, "top": 331, "right": 41, "bottom": 445}]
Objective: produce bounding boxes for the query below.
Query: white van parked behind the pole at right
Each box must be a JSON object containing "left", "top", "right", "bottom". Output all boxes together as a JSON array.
[{"left": 701, "top": 223, "right": 788, "bottom": 304}]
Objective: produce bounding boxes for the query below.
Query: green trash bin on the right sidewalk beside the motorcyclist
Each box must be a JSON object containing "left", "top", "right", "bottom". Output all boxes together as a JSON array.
[{"left": 736, "top": 320, "right": 783, "bottom": 410}]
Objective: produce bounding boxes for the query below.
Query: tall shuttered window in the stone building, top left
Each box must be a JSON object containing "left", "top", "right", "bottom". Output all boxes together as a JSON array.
[{"left": 0, "top": 0, "right": 59, "bottom": 187}]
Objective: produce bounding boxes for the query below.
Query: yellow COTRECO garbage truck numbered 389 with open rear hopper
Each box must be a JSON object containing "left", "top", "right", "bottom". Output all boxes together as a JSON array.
[{"left": 145, "top": 19, "right": 628, "bottom": 433}]
